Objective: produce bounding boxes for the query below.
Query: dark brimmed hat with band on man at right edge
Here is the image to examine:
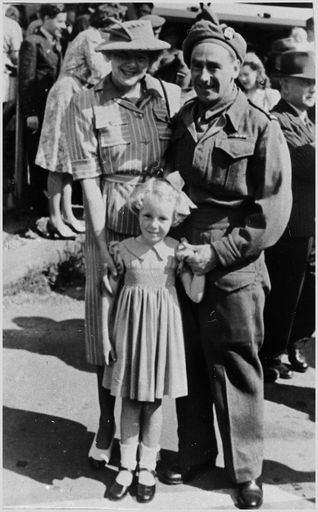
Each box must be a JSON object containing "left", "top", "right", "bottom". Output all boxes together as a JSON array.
[{"left": 280, "top": 50, "right": 315, "bottom": 80}]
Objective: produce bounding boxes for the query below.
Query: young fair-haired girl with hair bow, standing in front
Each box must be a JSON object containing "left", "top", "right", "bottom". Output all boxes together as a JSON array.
[{"left": 103, "top": 173, "right": 204, "bottom": 502}]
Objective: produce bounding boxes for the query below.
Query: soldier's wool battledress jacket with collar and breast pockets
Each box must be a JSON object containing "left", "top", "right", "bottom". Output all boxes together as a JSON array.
[{"left": 169, "top": 91, "right": 292, "bottom": 267}]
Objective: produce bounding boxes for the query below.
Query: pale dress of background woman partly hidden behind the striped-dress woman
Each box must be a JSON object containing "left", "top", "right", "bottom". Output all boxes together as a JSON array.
[{"left": 35, "top": 27, "right": 111, "bottom": 174}]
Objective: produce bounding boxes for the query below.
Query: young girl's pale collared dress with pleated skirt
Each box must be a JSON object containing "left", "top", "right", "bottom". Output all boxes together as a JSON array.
[{"left": 103, "top": 237, "right": 188, "bottom": 402}]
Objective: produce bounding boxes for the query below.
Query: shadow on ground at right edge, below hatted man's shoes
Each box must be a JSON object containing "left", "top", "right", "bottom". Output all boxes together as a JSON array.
[{"left": 264, "top": 383, "right": 315, "bottom": 421}]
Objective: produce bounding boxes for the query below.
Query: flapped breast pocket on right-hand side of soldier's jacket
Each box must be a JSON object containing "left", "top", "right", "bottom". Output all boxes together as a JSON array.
[{"left": 212, "top": 138, "right": 255, "bottom": 195}]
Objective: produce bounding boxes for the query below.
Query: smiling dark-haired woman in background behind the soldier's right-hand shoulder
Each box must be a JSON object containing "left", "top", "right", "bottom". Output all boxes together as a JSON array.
[{"left": 238, "top": 52, "right": 280, "bottom": 112}]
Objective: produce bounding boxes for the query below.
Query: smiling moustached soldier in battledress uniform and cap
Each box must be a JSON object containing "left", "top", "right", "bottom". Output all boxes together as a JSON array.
[{"left": 162, "top": 20, "right": 291, "bottom": 509}]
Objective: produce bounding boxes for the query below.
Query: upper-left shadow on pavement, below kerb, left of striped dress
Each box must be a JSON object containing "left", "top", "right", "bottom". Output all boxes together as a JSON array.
[{"left": 3, "top": 316, "right": 95, "bottom": 372}]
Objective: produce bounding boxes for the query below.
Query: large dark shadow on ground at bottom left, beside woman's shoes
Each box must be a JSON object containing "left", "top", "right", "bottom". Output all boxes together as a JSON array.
[{"left": 3, "top": 407, "right": 119, "bottom": 488}]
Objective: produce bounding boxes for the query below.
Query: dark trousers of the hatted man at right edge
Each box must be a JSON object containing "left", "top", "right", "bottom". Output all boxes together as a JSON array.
[{"left": 260, "top": 235, "right": 314, "bottom": 360}]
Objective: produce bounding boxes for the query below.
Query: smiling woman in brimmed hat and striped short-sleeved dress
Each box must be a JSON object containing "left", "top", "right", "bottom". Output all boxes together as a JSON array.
[{"left": 66, "top": 20, "right": 180, "bottom": 466}]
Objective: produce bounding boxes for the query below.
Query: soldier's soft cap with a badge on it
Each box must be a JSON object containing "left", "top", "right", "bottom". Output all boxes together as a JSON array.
[{"left": 183, "top": 20, "right": 247, "bottom": 67}]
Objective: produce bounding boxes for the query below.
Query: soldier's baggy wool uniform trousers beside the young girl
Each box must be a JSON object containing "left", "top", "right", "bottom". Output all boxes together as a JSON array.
[{"left": 176, "top": 255, "right": 269, "bottom": 483}]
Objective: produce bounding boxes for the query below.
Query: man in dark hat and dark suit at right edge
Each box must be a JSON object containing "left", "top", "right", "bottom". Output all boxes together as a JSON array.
[{"left": 261, "top": 51, "right": 315, "bottom": 381}]
